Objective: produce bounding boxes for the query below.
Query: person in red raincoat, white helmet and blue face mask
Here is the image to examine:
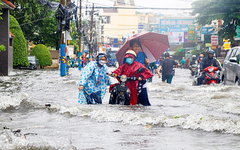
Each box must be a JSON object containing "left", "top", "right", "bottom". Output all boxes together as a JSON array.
[{"left": 109, "top": 50, "right": 153, "bottom": 106}]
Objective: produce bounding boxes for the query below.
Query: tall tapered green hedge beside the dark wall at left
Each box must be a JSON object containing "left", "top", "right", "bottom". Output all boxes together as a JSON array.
[{"left": 10, "top": 15, "right": 29, "bottom": 67}]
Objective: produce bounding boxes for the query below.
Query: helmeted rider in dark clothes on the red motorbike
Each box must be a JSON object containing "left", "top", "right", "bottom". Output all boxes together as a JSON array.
[{"left": 197, "top": 50, "right": 222, "bottom": 85}]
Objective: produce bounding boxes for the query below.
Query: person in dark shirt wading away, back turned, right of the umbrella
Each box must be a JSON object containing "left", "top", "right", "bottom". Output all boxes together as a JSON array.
[{"left": 157, "top": 53, "right": 178, "bottom": 84}]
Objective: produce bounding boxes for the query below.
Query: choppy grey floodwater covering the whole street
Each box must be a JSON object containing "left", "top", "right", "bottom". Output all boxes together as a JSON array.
[{"left": 0, "top": 68, "right": 240, "bottom": 150}]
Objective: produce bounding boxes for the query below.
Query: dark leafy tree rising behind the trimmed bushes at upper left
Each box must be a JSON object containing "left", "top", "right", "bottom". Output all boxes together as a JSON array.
[{"left": 10, "top": 0, "right": 60, "bottom": 48}]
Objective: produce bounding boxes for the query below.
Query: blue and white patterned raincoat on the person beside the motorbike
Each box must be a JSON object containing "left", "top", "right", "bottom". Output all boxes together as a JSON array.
[{"left": 78, "top": 61, "right": 111, "bottom": 104}]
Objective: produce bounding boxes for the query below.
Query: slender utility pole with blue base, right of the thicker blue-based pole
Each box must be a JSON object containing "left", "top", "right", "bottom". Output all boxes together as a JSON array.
[{"left": 78, "top": 0, "right": 82, "bottom": 70}]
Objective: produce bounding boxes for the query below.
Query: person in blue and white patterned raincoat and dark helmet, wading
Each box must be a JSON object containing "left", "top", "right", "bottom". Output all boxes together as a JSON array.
[{"left": 78, "top": 53, "right": 111, "bottom": 104}]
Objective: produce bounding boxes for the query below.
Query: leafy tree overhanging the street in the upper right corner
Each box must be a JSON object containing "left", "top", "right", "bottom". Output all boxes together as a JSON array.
[{"left": 192, "top": 0, "right": 240, "bottom": 42}]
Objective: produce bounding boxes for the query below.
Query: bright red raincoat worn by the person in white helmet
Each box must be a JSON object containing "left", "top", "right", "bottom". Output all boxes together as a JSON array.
[{"left": 113, "top": 61, "right": 153, "bottom": 105}]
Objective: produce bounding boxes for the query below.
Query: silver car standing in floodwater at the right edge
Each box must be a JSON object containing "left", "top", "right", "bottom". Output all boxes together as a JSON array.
[{"left": 221, "top": 46, "right": 240, "bottom": 85}]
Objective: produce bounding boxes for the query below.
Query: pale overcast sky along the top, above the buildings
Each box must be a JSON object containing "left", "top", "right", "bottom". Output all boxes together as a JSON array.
[{"left": 72, "top": 0, "right": 195, "bottom": 14}]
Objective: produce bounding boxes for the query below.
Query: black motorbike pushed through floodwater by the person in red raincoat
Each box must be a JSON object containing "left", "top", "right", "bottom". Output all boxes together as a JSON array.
[{"left": 109, "top": 68, "right": 145, "bottom": 105}]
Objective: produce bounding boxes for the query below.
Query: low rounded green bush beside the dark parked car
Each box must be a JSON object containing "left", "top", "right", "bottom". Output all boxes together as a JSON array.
[{"left": 30, "top": 44, "right": 52, "bottom": 67}]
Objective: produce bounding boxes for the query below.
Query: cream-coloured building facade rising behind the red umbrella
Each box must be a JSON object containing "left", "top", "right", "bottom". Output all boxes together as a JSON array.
[{"left": 98, "top": 0, "right": 138, "bottom": 44}]
